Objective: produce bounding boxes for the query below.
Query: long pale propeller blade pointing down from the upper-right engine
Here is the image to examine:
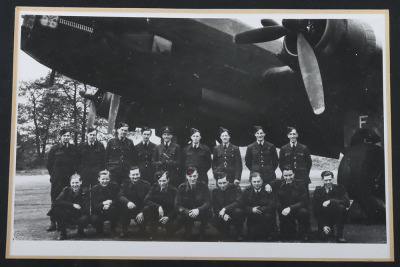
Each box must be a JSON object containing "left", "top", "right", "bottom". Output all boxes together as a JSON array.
[{"left": 297, "top": 32, "right": 325, "bottom": 115}]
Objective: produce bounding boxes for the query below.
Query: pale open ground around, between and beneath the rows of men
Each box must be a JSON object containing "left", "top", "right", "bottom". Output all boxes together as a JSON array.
[{"left": 13, "top": 154, "right": 386, "bottom": 243}]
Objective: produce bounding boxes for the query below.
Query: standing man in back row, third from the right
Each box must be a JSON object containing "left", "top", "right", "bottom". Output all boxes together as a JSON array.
[{"left": 212, "top": 127, "right": 242, "bottom": 185}]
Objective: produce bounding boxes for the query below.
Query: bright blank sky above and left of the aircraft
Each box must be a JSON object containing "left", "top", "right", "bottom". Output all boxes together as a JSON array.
[{"left": 17, "top": 14, "right": 384, "bottom": 81}]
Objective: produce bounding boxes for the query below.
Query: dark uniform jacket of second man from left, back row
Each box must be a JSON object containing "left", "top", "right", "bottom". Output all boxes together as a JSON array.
[{"left": 78, "top": 141, "right": 105, "bottom": 171}]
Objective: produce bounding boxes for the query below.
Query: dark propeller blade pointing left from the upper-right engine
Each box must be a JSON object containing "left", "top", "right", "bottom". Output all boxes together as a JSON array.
[{"left": 234, "top": 25, "right": 288, "bottom": 44}]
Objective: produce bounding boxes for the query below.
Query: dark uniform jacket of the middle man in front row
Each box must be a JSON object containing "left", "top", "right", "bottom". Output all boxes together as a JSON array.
[{"left": 175, "top": 182, "right": 211, "bottom": 213}]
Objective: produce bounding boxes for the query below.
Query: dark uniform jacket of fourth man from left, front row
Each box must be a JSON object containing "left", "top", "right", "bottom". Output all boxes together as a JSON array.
[{"left": 144, "top": 184, "right": 177, "bottom": 218}]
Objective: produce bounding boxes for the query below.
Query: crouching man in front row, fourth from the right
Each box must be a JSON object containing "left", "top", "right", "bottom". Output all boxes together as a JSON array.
[{"left": 212, "top": 172, "right": 244, "bottom": 241}]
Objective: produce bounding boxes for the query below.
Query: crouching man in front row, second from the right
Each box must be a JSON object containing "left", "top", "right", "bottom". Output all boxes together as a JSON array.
[{"left": 271, "top": 165, "right": 310, "bottom": 241}]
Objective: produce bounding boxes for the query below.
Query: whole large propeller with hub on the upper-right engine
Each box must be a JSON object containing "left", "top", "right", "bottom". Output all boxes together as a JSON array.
[{"left": 234, "top": 19, "right": 325, "bottom": 115}]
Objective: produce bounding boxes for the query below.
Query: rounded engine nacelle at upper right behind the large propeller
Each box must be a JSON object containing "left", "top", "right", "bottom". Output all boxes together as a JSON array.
[{"left": 278, "top": 19, "right": 377, "bottom": 75}]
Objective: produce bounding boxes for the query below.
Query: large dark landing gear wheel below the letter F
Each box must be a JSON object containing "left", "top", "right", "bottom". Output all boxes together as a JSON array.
[{"left": 338, "top": 129, "right": 386, "bottom": 224}]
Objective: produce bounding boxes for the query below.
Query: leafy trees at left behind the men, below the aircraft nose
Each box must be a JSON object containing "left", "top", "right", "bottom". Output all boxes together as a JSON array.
[{"left": 17, "top": 72, "right": 95, "bottom": 165}]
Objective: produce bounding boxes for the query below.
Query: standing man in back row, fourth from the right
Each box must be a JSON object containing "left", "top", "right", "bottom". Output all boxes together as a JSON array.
[{"left": 182, "top": 128, "right": 211, "bottom": 186}]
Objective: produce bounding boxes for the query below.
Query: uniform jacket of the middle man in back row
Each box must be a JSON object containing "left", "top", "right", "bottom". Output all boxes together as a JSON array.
[{"left": 153, "top": 142, "right": 182, "bottom": 175}]
